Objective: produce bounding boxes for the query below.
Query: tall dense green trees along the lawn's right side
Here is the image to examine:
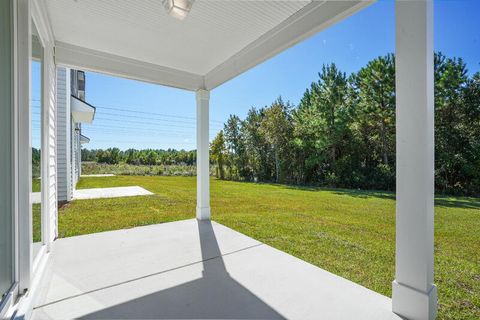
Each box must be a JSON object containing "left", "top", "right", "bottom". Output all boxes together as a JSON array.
[{"left": 211, "top": 53, "right": 480, "bottom": 196}]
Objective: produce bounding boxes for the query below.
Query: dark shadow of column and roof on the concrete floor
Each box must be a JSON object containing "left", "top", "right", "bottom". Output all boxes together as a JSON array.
[{"left": 81, "top": 221, "right": 284, "bottom": 319}]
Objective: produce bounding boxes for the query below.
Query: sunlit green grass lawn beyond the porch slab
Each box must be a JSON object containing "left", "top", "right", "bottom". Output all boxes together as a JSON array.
[{"left": 59, "top": 176, "right": 480, "bottom": 319}]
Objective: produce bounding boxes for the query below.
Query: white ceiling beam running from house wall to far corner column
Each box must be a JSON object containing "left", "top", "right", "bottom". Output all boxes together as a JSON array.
[{"left": 55, "top": 41, "right": 204, "bottom": 90}]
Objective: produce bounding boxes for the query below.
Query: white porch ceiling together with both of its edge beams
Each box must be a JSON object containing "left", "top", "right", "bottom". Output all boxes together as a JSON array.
[{"left": 41, "top": 0, "right": 372, "bottom": 90}]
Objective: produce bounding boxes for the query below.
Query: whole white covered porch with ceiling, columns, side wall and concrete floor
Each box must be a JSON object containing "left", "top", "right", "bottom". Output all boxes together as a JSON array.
[{"left": 0, "top": 0, "right": 437, "bottom": 319}]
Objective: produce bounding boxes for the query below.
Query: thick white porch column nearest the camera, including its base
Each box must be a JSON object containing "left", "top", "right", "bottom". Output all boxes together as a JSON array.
[{"left": 392, "top": 0, "right": 437, "bottom": 319}]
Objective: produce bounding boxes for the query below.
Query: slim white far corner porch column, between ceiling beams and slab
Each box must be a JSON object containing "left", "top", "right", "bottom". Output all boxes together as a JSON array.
[{"left": 196, "top": 89, "right": 210, "bottom": 220}]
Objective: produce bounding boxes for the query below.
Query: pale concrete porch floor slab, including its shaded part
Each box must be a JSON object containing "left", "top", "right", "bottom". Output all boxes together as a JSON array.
[{"left": 33, "top": 219, "right": 400, "bottom": 320}]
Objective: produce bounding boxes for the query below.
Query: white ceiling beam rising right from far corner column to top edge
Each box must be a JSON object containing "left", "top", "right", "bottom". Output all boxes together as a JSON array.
[{"left": 205, "top": 0, "right": 375, "bottom": 90}]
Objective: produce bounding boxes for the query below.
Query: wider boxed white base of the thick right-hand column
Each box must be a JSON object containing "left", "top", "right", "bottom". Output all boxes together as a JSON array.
[{"left": 392, "top": 280, "right": 437, "bottom": 320}]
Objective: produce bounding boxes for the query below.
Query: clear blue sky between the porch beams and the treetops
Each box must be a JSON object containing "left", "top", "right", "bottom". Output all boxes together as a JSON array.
[{"left": 34, "top": 0, "right": 480, "bottom": 149}]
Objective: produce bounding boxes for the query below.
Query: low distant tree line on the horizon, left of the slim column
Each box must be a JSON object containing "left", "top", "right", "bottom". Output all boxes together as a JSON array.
[{"left": 82, "top": 148, "right": 196, "bottom": 166}]
